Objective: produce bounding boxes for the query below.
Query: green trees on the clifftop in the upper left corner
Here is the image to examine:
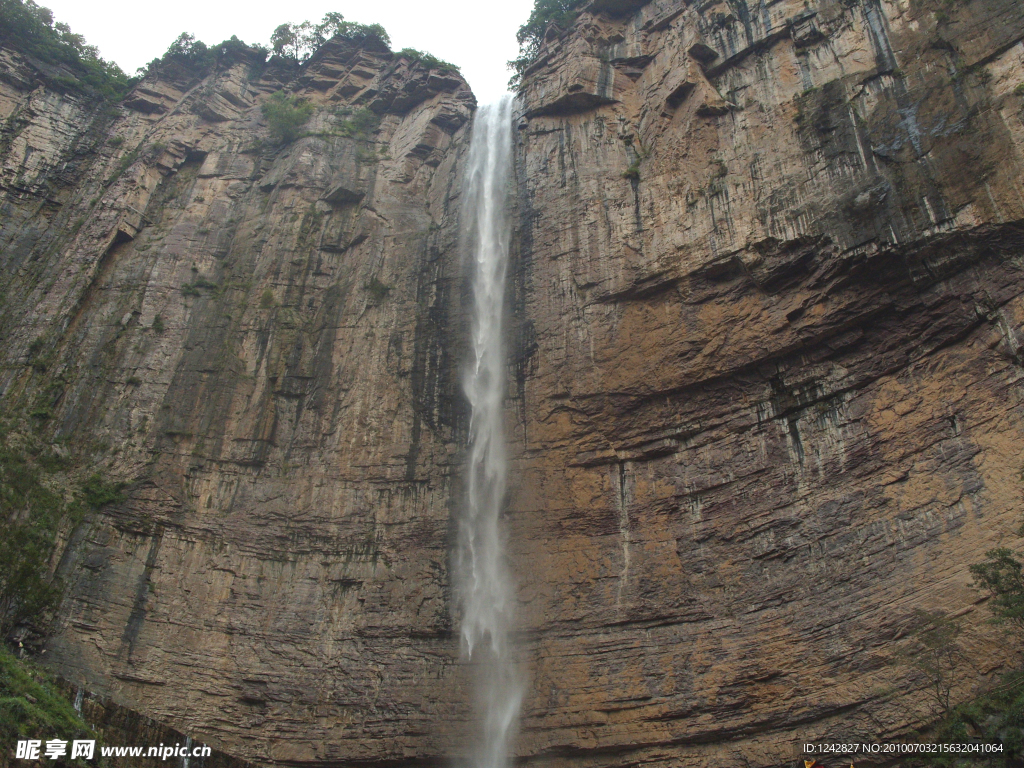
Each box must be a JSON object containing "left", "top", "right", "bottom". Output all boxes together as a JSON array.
[{"left": 0, "top": 0, "right": 132, "bottom": 101}]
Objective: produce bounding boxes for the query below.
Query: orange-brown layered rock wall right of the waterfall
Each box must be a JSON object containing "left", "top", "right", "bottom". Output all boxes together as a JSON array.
[{"left": 509, "top": 0, "right": 1024, "bottom": 766}]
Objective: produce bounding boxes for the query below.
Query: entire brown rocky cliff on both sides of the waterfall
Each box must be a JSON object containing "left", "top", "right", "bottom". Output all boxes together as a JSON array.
[{"left": 0, "top": 0, "right": 1024, "bottom": 768}]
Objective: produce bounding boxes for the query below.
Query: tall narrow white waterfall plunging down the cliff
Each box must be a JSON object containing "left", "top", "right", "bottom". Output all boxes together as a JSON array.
[{"left": 458, "top": 96, "right": 522, "bottom": 768}]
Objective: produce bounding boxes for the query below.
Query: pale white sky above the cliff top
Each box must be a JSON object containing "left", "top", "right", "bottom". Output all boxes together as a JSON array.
[{"left": 37, "top": 0, "right": 534, "bottom": 104}]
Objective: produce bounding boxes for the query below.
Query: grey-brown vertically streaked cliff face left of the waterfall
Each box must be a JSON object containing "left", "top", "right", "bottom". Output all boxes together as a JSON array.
[{"left": 0, "top": 34, "right": 475, "bottom": 761}]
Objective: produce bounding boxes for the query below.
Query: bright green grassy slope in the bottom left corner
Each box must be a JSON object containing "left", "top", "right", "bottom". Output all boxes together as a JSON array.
[{"left": 0, "top": 645, "right": 99, "bottom": 766}]
